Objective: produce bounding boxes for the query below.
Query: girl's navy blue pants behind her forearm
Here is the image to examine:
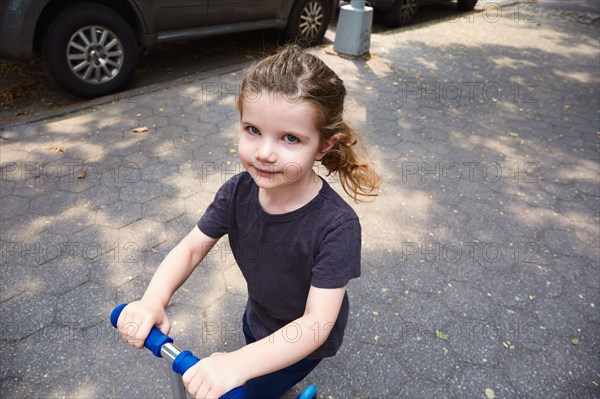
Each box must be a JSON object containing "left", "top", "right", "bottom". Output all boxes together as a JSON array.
[{"left": 243, "top": 313, "right": 321, "bottom": 399}]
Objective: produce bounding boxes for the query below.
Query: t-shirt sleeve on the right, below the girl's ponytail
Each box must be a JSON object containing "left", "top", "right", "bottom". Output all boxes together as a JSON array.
[{"left": 311, "top": 219, "right": 361, "bottom": 288}]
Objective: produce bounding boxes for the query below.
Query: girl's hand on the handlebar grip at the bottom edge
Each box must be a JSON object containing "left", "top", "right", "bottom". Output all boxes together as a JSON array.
[{"left": 183, "top": 352, "right": 246, "bottom": 399}]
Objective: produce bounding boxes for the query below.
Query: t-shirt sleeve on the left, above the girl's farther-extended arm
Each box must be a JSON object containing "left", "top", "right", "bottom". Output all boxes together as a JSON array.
[{"left": 198, "top": 175, "right": 239, "bottom": 239}]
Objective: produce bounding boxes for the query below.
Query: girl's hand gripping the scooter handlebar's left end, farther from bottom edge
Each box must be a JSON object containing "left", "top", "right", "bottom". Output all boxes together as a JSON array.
[{"left": 117, "top": 299, "right": 171, "bottom": 349}]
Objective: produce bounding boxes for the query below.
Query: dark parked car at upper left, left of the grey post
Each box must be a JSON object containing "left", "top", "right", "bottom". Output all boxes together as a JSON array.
[{"left": 0, "top": 0, "right": 337, "bottom": 98}]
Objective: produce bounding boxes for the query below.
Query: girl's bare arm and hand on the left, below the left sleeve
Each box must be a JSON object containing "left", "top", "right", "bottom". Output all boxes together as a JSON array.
[{"left": 117, "top": 226, "right": 218, "bottom": 349}]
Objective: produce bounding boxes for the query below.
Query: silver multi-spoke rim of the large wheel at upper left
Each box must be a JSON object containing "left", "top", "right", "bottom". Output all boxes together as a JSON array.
[{"left": 67, "top": 25, "right": 125, "bottom": 84}]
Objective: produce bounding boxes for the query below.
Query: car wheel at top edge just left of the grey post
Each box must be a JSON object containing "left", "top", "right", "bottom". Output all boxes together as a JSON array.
[{"left": 286, "top": 0, "right": 331, "bottom": 46}]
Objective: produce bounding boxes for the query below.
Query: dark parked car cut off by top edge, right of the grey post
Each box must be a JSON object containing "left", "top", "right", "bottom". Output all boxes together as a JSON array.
[{"left": 368, "top": 0, "right": 477, "bottom": 28}]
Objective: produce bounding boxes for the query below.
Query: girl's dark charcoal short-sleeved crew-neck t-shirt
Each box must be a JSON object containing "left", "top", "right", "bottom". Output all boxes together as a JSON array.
[{"left": 198, "top": 172, "right": 361, "bottom": 359}]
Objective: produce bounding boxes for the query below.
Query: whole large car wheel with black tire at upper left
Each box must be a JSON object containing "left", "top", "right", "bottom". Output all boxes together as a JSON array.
[{"left": 43, "top": 4, "right": 138, "bottom": 98}]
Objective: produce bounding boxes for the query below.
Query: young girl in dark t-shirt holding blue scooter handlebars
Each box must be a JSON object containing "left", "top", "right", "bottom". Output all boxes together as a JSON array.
[{"left": 118, "top": 45, "right": 379, "bottom": 399}]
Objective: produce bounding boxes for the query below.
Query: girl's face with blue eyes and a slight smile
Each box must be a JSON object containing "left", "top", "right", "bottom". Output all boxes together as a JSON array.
[{"left": 238, "top": 91, "right": 328, "bottom": 189}]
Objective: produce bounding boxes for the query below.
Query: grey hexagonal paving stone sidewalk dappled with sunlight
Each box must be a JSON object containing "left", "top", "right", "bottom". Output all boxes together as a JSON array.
[{"left": 0, "top": 5, "right": 600, "bottom": 399}]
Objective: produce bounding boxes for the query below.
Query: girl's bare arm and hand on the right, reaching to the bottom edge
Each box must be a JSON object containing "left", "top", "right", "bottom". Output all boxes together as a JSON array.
[{"left": 183, "top": 287, "right": 346, "bottom": 398}]
